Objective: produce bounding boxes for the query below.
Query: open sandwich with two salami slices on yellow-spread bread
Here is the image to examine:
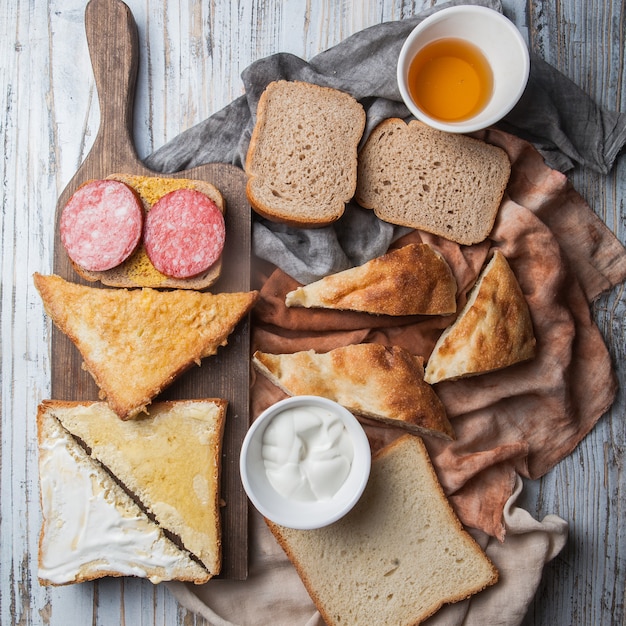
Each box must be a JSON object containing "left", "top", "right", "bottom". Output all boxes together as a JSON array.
[{"left": 59, "top": 174, "right": 226, "bottom": 289}]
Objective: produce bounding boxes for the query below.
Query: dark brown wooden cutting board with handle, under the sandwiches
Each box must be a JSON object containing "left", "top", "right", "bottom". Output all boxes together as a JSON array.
[{"left": 51, "top": 0, "right": 251, "bottom": 580}]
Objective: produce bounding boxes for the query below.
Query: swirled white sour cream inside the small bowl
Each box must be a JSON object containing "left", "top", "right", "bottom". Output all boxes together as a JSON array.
[{"left": 261, "top": 406, "right": 354, "bottom": 501}]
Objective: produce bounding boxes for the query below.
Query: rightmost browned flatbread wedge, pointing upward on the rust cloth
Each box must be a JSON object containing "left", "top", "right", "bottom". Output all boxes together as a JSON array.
[{"left": 425, "top": 249, "right": 536, "bottom": 384}]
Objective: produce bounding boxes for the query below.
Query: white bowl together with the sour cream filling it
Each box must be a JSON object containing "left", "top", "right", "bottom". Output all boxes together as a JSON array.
[{"left": 239, "top": 396, "right": 371, "bottom": 530}]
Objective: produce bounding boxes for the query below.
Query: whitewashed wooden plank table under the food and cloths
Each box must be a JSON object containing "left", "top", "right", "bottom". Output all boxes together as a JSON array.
[{"left": 0, "top": 0, "right": 626, "bottom": 626}]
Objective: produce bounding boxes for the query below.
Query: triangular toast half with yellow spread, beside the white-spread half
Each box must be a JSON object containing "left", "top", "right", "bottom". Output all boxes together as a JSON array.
[{"left": 40, "top": 399, "right": 226, "bottom": 575}]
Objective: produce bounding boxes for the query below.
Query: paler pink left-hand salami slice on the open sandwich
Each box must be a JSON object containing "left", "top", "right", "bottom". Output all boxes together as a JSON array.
[{"left": 59, "top": 180, "right": 143, "bottom": 272}]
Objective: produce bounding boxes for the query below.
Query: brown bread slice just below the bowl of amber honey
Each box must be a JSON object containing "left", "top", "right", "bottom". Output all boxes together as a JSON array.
[{"left": 356, "top": 118, "right": 511, "bottom": 245}]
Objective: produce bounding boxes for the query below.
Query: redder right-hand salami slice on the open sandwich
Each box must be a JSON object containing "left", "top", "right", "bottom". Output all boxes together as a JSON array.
[{"left": 144, "top": 189, "right": 226, "bottom": 278}]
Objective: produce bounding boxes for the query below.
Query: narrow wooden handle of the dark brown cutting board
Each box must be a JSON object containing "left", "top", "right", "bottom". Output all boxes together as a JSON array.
[{"left": 85, "top": 0, "right": 140, "bottom": 169}]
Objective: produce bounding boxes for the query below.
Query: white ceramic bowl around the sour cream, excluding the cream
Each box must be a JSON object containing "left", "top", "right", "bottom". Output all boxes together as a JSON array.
[{"left": 239, "top": 396, "right": 371, "bottom": 530}]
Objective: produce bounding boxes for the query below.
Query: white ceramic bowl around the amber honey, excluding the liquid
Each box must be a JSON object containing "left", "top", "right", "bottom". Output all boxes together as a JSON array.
[{"left": 397, "top": 5, "right": 530, "bottom": 133}]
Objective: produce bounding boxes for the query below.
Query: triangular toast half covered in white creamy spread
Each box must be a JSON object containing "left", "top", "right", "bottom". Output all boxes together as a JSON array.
[{"left": 37, "top": 404, "right": 211, "bottom": 585}]
